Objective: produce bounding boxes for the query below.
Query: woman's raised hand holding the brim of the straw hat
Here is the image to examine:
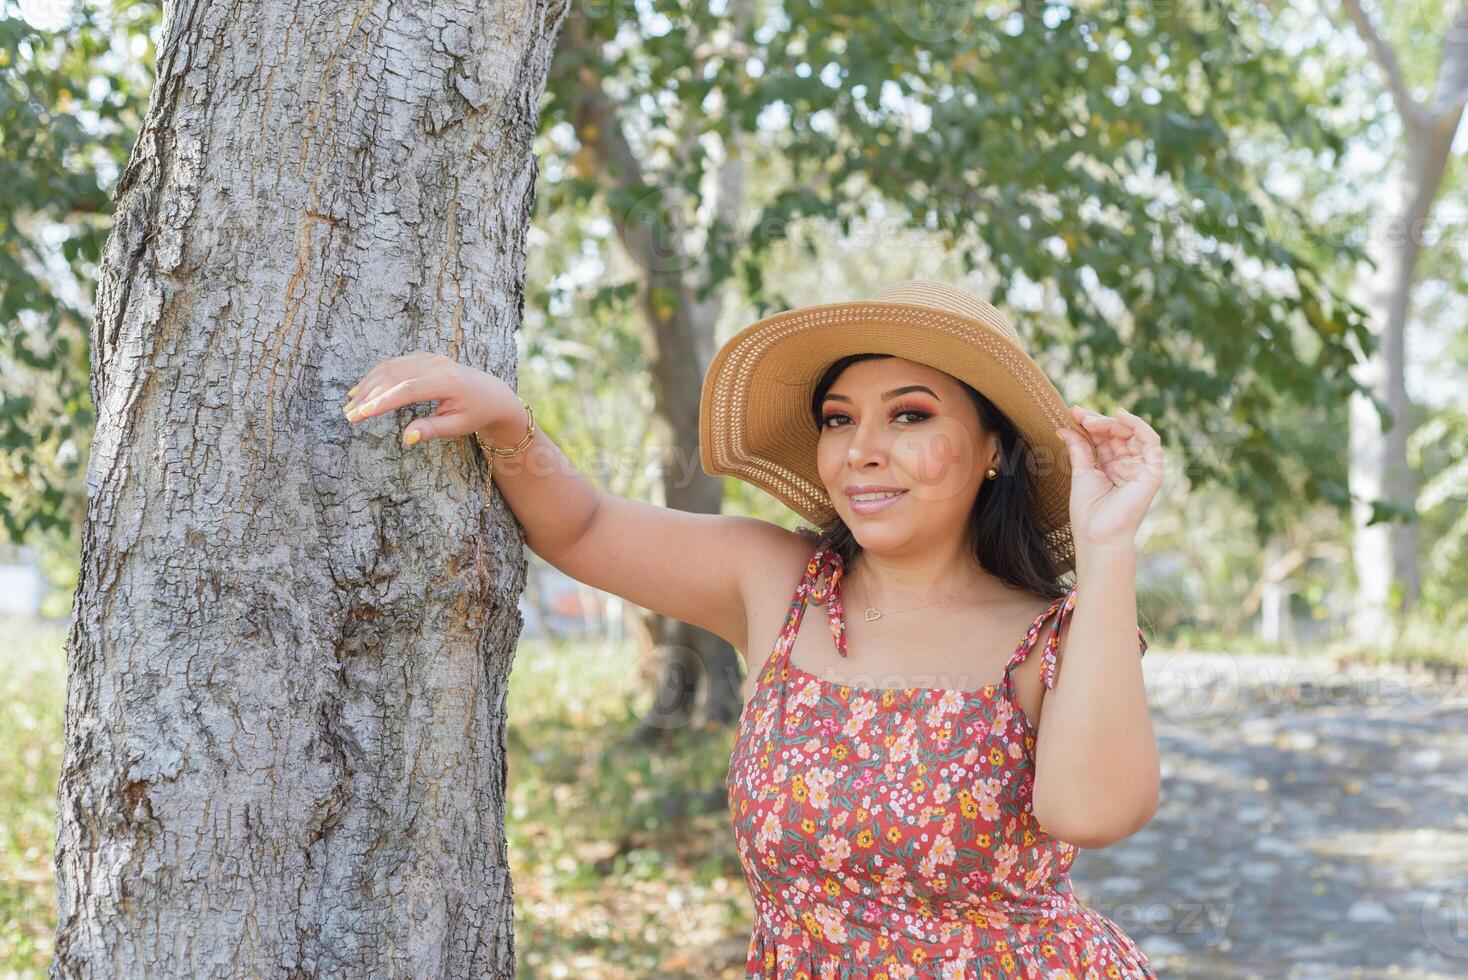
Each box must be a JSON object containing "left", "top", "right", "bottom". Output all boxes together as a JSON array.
[{"left": 1060, "top": 405, "right": 1163, "bottom": 550}]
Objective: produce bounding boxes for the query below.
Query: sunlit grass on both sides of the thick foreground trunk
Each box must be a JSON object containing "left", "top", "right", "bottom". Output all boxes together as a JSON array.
[{"left": 0, "top": 619, "right": 753, "bottom": 977}]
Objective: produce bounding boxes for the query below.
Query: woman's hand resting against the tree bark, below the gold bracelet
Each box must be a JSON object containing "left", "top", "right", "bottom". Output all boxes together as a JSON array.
[{"left": 342, "top": 352, "right": 526, "bottom": 446}]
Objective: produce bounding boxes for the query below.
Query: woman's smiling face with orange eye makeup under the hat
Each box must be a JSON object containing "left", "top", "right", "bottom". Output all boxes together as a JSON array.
[{"left": 816, "top": 356, "right": 998, "bottom": 550}]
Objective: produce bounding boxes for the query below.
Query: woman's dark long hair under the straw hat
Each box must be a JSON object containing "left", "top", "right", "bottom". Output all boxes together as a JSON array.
[{"left": 800, "top": 354, "right": 1067, "bottom": 599}]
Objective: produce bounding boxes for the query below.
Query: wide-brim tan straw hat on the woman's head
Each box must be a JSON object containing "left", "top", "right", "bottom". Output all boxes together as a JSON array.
[{"left": 699, "top": 279, "right": 1094, "bottom": 574}]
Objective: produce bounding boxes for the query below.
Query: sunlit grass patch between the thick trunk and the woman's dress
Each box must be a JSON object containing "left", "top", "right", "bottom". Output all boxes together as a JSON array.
[{"left": 506, "top": 630, "right": 753, "bottom": 977}]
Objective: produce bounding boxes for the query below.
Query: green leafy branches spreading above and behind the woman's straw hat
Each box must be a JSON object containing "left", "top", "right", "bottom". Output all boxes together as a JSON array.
[{"left": 537, "top": 0, "right": 1374, "bottom": 551}]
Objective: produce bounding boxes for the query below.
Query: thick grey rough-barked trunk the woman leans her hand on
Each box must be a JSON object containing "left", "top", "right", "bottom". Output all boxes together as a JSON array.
[{"left": 51, "top": 0, "right": 565, "bottom": 977}]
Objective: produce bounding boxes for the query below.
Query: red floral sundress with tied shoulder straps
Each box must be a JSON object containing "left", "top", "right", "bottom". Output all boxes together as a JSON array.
[{"left": 727, "top": 549, "right": 1157, "bottom": 980}]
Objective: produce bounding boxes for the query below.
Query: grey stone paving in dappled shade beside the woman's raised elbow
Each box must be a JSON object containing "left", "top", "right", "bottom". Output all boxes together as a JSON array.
[{"left": 1072, "top": 650, "right": 1468, "bottom": 980}]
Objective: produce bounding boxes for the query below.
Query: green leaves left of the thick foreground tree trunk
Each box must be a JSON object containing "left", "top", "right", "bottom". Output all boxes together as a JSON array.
[{"left": 0, "top": 0, "right": 160, "bottom": 540}]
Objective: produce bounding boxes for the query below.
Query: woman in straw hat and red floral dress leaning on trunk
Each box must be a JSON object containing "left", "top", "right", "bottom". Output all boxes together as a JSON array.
[{"left": 337, "top": 280, "right": 1161, "bottom": 979}]
